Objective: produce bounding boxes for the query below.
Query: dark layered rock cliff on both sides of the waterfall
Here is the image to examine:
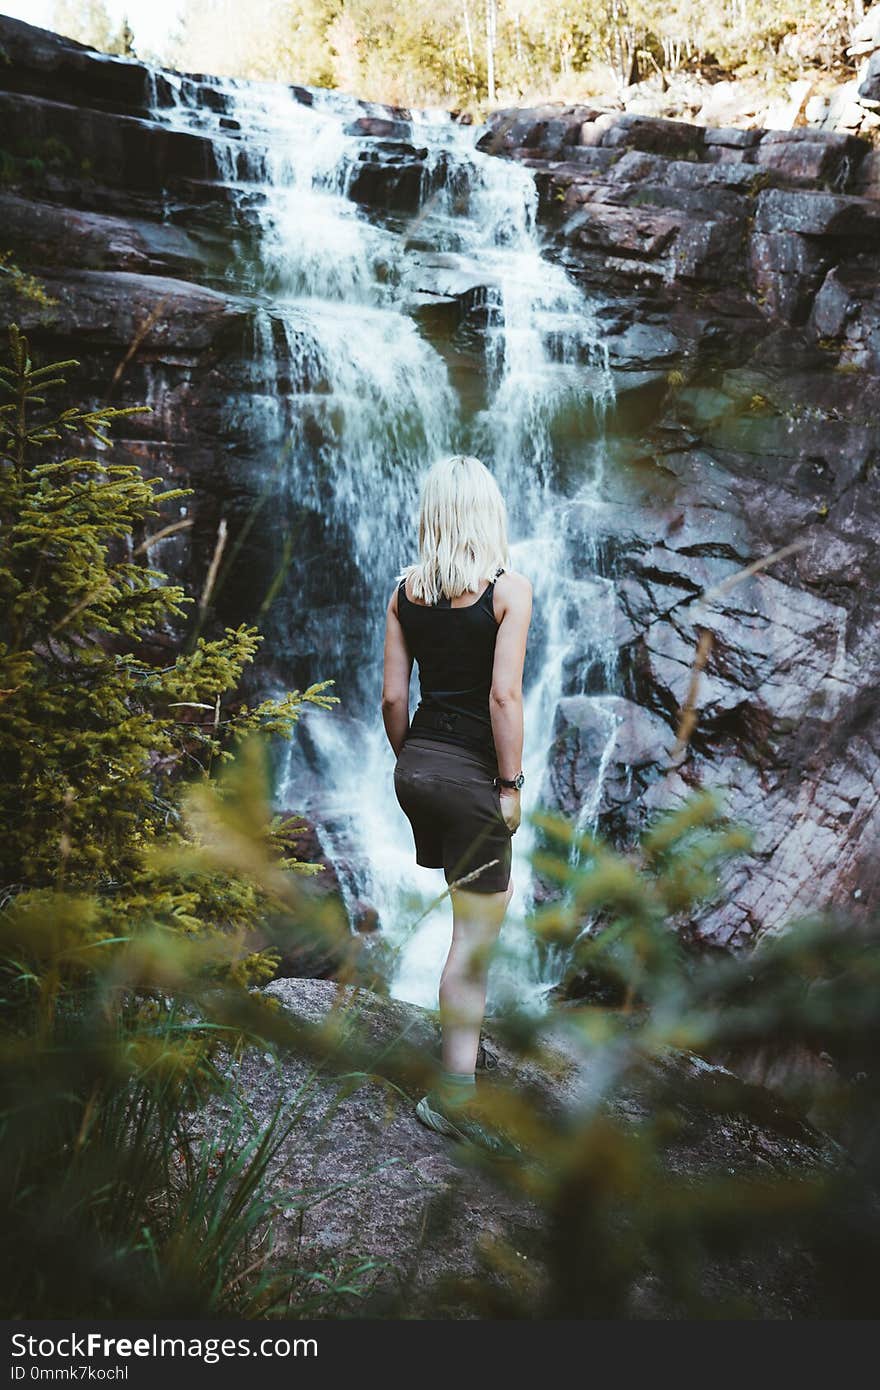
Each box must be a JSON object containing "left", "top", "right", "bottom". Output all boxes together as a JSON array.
[{"left": 0, "top": 11, "right": 880, "bottom": 947}]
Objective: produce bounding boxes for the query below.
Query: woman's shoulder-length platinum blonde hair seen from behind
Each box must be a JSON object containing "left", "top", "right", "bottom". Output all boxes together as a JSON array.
[{"left": 398, "top": 453, "right": 510, "bottom": 605}]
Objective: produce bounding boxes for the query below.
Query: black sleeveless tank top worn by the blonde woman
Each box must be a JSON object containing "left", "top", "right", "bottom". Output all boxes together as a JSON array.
[{"left": 398, "top": 569, "right": 503, "bottom": 760}]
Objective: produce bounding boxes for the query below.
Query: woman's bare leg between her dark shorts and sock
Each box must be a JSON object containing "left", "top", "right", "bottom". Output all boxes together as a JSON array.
[{"left": 439, "top": 880, "right": 513, "bottom": 1076}]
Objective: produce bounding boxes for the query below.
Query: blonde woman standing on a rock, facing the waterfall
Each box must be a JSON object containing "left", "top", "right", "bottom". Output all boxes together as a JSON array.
[{"left": 382, "top": 455, "right": 531, "bottom": 1150}]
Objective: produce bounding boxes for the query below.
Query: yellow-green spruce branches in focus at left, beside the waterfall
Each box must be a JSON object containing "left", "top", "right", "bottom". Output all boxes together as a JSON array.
[{"left": 0, "top": 328, "right": 332, "bottom": 894}]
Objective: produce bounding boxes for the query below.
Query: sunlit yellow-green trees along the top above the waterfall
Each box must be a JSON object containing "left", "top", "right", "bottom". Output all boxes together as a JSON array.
[{"left": 53, "top": 0, "right": 865, "bottom": 108}]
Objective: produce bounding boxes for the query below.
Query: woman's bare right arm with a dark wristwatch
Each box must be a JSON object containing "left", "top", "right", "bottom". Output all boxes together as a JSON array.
[{"left": 489, "top": 573, "right": 531, "bottom": 830}]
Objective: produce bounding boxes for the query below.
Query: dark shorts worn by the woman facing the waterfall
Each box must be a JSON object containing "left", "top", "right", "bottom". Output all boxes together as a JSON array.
[{"left": 395, "top": 737, "right": 512, "bottom": 892}]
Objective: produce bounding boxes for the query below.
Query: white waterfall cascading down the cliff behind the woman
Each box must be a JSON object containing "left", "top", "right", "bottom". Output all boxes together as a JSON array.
[{"left": 145, "top": 75, "right": 614, "bottom": 1006}]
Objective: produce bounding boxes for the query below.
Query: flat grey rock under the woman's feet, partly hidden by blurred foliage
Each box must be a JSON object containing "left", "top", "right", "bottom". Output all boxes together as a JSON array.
[{"left": 212, "top": 980, "right": 830, "bottom": 1318}]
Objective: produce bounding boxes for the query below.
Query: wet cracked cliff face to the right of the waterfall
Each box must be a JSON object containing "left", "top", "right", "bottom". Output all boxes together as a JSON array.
[{"left": 482, "top": 107, "right": 880, "bottom": 947}]
